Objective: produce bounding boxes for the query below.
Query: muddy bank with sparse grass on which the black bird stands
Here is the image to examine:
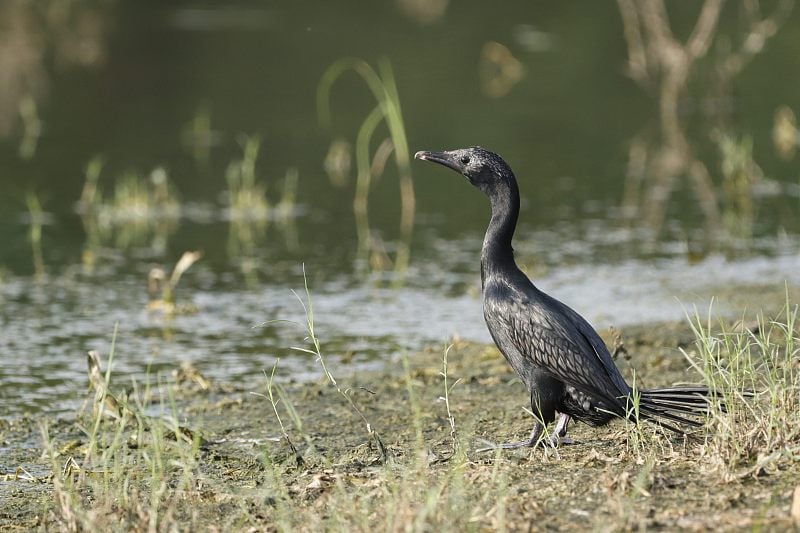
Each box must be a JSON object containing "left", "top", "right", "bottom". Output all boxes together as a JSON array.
[{"left": 0, "top": 284, "right": 800, "bottom": 530}]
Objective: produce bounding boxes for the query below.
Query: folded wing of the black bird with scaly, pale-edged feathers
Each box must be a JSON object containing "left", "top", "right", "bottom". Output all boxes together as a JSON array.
[{"left": 485, "top": 290, "right": 627, "bottom": 410}]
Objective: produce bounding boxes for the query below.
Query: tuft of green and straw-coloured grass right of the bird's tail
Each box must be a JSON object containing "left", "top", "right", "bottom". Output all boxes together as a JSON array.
[{"left": 686, "top": 293, "right": 800, "bottom": 479}]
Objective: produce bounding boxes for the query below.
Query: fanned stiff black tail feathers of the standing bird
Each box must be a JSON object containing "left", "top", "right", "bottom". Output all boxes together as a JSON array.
[{"left": 639, "top": 386, "right": 725, "bottom": 434}]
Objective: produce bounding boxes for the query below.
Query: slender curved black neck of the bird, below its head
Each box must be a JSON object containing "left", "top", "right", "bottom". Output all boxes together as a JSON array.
[{"left": 481, "top": 178, "right": 519, "bottom": 271}]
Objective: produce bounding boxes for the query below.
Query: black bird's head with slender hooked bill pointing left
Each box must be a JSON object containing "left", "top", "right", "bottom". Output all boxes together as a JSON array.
[{"left": 414, "top": 146, "right": 516, "bottom": 196}]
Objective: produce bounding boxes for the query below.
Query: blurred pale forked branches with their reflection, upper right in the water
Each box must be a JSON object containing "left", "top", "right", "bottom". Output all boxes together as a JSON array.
[{"left": 618, "top": 0, "right": 793, "bottom": 248}]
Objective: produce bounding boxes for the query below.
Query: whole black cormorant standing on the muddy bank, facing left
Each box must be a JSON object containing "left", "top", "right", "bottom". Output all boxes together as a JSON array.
[{"left": 414, "top": 146, "right": 709, "bottom": 448}]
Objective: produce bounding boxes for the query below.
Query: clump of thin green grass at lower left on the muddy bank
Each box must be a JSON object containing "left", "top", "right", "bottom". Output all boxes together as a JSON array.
[{"left": 41, "top": 331, "right": 205, "bottom": 531}]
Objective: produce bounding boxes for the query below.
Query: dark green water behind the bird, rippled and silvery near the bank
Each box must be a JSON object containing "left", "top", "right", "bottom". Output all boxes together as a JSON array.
[{"left": 0, "top": 0, "right": 800, "bottom": 416}]
